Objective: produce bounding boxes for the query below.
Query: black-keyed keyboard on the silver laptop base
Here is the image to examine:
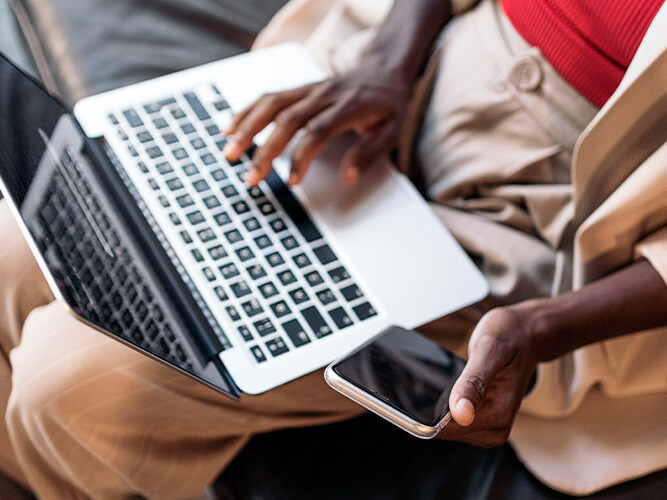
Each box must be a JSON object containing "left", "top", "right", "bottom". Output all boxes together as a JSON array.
[{"left": 108, "top": 86, "right": 377, "bottom": 364}]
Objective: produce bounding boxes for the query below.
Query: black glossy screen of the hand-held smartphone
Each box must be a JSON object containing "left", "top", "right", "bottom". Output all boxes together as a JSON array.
[{"left": 332, "top": 326, "right": 465, "bottom": 426}]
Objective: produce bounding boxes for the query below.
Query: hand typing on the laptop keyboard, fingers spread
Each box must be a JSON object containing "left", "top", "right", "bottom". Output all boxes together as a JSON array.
[{"left": 224, "top": 65, "right": 409, "bottom": 185}]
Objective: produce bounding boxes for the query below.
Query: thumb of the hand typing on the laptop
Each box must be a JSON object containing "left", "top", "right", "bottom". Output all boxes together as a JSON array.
[{"left": 341, "top": 121, "right": 397, "bottom": 186}]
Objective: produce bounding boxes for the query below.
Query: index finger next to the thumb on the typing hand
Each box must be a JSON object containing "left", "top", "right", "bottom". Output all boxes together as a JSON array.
[{"left": 289, "top": 101, "right": 384, "bottom": 184}]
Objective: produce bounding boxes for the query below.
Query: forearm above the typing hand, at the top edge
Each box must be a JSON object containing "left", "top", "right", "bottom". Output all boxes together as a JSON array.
[{"left": 366, "top": 0, "right": 451, "bottom": 83}]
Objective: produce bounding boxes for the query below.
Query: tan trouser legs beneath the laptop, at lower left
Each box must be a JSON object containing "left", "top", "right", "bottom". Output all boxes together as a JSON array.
[{"left": 0, "top": 198, "right": 363, "bottom": 497}]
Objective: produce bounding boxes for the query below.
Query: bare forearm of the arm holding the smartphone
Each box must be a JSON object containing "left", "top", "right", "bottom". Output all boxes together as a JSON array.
[{"left": 512, "top": 260, "right": 667, "bottom": 361}]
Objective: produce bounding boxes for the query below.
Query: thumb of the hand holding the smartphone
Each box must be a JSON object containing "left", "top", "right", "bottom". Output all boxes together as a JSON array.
[{"left": 449, "top": 338, "right": 510, "bottom": 426}]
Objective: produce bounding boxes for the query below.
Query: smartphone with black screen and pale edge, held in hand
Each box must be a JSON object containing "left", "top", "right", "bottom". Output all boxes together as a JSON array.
[{"left": 324, "top": 326, "right": 466, "bottom": 439}]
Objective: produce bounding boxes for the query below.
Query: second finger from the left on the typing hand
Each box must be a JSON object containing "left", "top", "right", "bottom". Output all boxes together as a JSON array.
[{"left": 246, "top": 92, "right": 330, "bottom": 186}]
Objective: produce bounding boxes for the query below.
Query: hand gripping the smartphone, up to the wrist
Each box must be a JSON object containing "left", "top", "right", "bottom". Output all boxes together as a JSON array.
[{"left": 438, "top": 308, "right": 538, "bottom": 447}]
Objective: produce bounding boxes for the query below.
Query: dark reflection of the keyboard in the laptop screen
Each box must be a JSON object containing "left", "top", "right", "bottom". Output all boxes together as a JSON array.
[{"left": 37, "top": 149, "right": 194, "bottom": 372}]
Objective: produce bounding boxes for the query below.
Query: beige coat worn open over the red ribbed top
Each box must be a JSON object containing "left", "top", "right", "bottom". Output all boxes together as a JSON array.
[{"left": 256, "top": 0, "right": 667, "bottom": 494}]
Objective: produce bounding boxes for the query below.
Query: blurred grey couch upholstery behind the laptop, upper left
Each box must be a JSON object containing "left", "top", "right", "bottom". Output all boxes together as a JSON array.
[{"left": 11, "top": 0, "right": 286, "bottom": 105}]
